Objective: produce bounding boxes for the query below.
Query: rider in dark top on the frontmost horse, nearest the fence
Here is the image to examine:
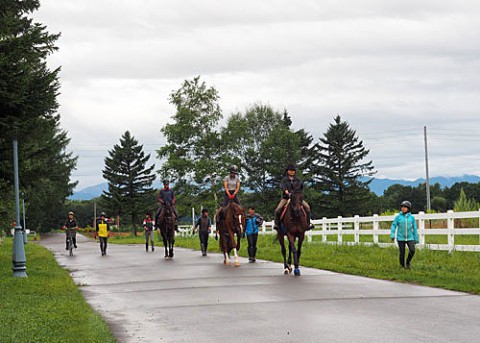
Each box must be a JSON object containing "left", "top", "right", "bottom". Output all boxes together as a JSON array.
[{"left": 273, "top": 164, "right": 314, "bottom": 231}]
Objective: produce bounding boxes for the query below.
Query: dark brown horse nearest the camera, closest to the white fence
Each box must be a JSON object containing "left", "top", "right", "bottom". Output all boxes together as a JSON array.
[{"left": 277, "top": 192, "right": 308, "bottom": 276}]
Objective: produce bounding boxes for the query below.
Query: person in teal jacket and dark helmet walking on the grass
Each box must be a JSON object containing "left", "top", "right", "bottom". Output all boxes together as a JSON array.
[{"left": 390, "top": 201, "right": 418, "bottom": 269}]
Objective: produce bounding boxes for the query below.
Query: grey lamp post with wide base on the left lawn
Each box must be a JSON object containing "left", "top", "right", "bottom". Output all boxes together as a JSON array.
[{"left": 12, "top": 138, "right": 27, "bottom": 277}]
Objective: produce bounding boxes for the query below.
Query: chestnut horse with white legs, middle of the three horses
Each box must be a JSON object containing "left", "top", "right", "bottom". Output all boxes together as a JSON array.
[{"left": 217, "top": 201, "right": 245, "bottom": 267}]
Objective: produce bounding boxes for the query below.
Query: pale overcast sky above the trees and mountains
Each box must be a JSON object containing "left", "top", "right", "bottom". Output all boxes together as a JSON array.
[{"left": 34, "top": 0, "right": 480, "bottom": 190}]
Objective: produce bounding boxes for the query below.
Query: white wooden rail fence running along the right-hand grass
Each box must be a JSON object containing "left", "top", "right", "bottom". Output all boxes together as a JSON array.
[{"left": 179, "top": 210, "right": 480, "bottom": 252}]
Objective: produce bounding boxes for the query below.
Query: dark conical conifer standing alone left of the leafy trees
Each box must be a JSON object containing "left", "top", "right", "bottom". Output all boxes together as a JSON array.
[{"left": 102, "top": 131, "right": 155, "bottom": 235}]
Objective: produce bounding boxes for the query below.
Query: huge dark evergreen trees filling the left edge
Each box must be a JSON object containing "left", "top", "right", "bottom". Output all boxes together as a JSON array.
[{"left": 0, "top": 0, "right": 76, "bottom": 231}]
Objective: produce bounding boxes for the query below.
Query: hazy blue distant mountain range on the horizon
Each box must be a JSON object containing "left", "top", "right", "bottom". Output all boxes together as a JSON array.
[{"left": 69, "top": 175, "right": 480, "bottom": 200}]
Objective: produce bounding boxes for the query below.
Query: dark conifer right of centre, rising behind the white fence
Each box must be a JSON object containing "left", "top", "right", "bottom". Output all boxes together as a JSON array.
[{"left": 315, "top": 116, "right": 375, "bottom": 217}]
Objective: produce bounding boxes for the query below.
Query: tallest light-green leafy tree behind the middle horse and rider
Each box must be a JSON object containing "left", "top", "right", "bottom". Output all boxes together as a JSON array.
[{"left": 157, "top": 76, "right": 223, "bottom": 208}]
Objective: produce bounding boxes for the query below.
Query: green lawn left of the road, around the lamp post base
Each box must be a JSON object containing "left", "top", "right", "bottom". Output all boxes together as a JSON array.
[{"left": 0, "top": 239, "right": 115, "bottom": 342}]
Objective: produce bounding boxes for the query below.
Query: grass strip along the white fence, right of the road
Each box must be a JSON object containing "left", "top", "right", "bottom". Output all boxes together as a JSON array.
[{"left": 111, "top": 235, "right": 480, "bottom": 294}]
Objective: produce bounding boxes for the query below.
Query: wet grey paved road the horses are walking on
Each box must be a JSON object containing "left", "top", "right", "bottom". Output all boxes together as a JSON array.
[{"left": 41, "top": 235, "right": 480, "bottom": 343}]
